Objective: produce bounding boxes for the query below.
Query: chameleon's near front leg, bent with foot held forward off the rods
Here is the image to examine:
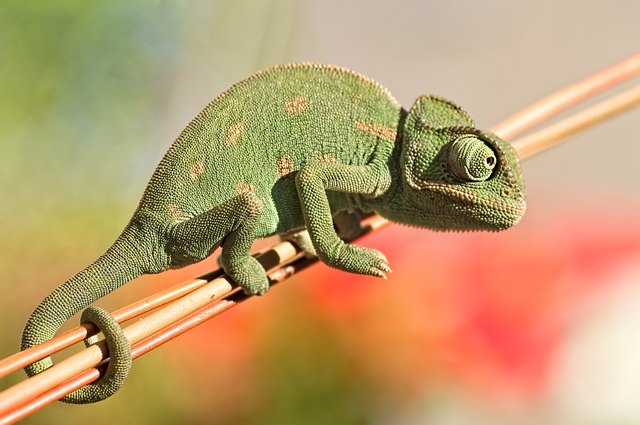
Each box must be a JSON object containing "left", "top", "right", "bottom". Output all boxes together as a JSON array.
[{"left": 296, "top": 162, "right": 391, "bottom": 277}]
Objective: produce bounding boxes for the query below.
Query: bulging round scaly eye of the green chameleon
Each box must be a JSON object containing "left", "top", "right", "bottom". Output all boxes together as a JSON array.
[{"left": 449, "top": 136, "right": 498, "bottom": 182}]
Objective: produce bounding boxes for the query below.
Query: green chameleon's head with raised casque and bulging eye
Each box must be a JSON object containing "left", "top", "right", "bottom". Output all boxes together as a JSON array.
[{"left": 401, "top": 96, "right": 525, "bottom": 231}]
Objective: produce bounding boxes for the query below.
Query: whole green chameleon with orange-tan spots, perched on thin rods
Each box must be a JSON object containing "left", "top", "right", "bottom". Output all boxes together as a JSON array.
[{"left": 22, "top": 64, "right": 525, "bottom": 403}]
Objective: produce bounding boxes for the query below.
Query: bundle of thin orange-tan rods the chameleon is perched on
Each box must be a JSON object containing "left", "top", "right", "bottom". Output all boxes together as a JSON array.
[{"left": 0, "top": 52, "right": 640, "bottom": 424}]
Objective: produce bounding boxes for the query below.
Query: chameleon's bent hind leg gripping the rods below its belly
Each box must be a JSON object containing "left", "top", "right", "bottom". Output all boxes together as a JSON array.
[{"left": 169, "top": 191, "right": 269, "bottom": 295}]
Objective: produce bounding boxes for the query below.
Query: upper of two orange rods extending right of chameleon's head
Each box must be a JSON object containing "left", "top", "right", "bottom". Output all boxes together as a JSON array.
[{"left": 493, "top": 52, "right": 640, "bottom": 140}]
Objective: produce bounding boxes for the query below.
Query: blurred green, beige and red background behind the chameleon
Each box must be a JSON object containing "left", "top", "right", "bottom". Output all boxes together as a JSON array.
[{"left": 0, "top": 0, "right": 640, "bottom": 425}]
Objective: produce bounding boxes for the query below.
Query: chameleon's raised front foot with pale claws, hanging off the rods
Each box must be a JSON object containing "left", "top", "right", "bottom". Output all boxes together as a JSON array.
[{"left": 325, "top": 243, "right": 391, "bottom": 278}]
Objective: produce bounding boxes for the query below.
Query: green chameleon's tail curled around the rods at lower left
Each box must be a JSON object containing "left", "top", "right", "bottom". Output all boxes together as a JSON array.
[{"left": 21, "top": 227, "right": 145, "bottom": 404}]
